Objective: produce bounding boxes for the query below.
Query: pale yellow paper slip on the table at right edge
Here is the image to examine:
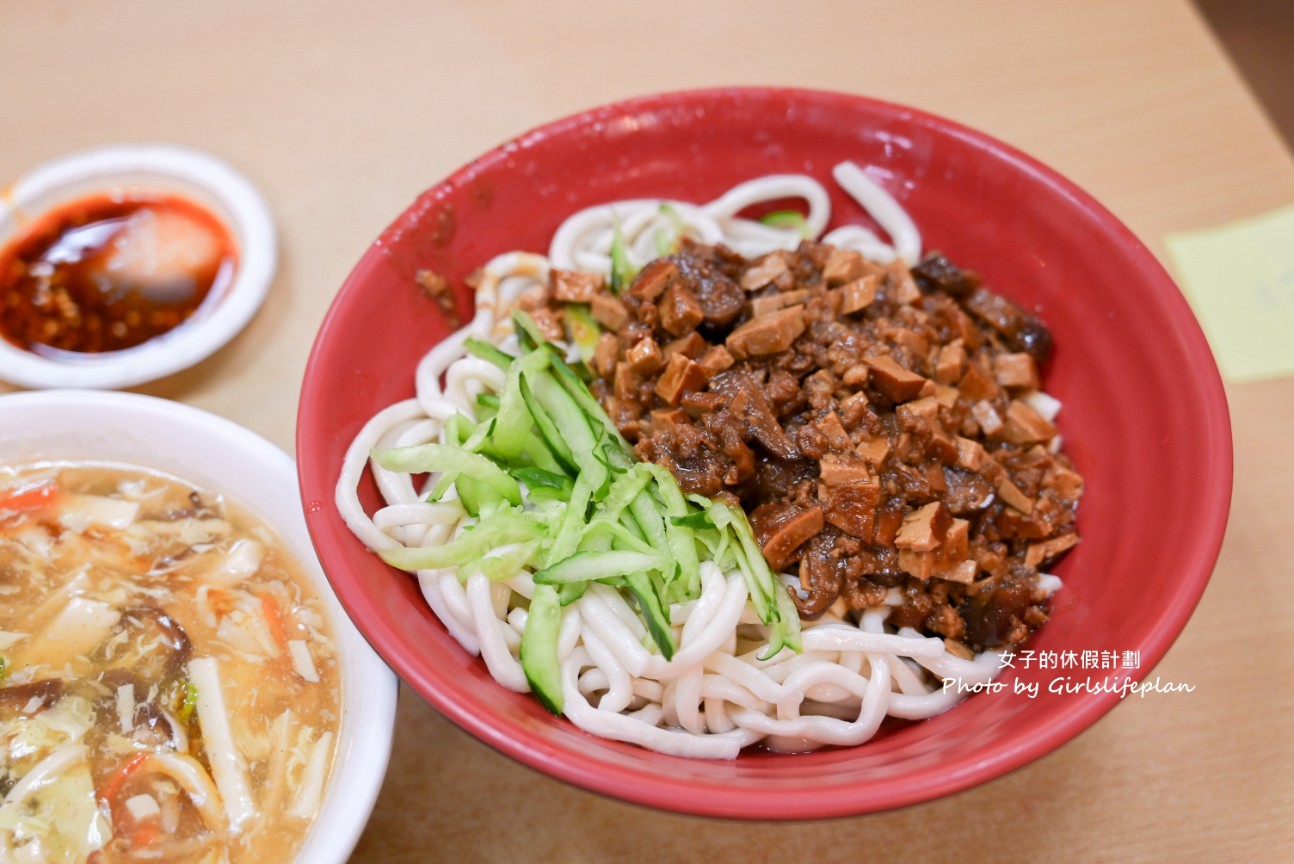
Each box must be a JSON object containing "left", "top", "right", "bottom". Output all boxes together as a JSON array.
[{"left": 1163, "top": 206, "right": 1294, "bottom": 380}]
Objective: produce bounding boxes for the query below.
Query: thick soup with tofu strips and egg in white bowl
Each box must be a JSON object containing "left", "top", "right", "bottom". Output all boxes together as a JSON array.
[{"left": 0, "top": 463, "right": 340, "bottom": 864}]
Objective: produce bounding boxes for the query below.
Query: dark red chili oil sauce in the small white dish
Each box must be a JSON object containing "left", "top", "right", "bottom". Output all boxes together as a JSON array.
[{"left": 0, "top": 194, "right": 237, "bottom": 357}]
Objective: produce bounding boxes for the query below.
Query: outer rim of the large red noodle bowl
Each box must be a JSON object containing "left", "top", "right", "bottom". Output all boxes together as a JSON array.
[{"left": 296, "top": 87, "right": 1233, "bottom": 820}]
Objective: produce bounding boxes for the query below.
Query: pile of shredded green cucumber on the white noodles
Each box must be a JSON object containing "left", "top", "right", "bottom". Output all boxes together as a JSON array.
[{"left": 373, "top": 305, "right": 800, "bottom": 714}]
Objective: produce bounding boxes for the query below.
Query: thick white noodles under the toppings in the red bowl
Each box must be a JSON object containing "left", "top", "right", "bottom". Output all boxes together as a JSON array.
[{"left": 336, "top": 163, "right": 1040, "bottom": 759}]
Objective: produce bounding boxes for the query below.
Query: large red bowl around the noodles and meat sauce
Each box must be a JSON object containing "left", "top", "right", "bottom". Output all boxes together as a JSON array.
[{"left": 296, "top": 88, "right": 1232, "bottom": 819}]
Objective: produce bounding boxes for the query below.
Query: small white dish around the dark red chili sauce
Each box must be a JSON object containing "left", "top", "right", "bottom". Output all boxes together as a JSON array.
[{"left": 0, "top": 144, "right": 278, "bottom": 389}]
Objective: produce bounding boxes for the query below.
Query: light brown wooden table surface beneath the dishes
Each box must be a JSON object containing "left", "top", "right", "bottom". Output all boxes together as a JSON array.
[{"left": 0, "top": 0, "right": 1294, "bottom": 863}]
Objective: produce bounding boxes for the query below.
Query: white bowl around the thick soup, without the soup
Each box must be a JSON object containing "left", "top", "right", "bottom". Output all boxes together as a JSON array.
[{"left": 0, "top": 389, "right": 397, "bottom": 864}]
